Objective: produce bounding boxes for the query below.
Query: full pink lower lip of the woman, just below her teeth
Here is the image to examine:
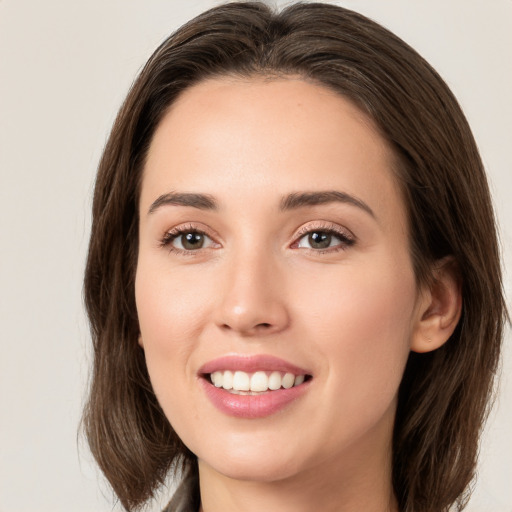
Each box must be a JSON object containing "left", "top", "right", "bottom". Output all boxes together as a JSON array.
[{"left": 200, "top": 378, "right": 310, "bottom": 419}]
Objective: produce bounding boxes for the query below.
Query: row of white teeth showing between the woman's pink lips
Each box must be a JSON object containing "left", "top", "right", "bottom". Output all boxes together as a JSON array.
[{"left": 210, "top": 370, "right": 305, "bottom": 394}]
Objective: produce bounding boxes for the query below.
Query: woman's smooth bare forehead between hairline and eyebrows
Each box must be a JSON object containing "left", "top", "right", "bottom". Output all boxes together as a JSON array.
[{"left": 141, "top": 78, "right": 404, "bottom": 229}]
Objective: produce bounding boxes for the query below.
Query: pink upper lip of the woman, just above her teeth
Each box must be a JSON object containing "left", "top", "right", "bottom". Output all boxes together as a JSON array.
[{"left": 199, "top": 354, "right": 311, "bottom": 375}]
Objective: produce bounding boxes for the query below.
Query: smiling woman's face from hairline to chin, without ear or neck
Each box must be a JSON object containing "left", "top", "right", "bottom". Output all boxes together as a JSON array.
[{"left": 136, "top": 78, "right": 420, "bottom": 481}]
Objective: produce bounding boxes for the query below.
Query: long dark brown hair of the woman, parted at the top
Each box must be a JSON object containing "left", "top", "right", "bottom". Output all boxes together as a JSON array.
[{"left": 84, "top": 2, "right": 506, "bottom": 512}]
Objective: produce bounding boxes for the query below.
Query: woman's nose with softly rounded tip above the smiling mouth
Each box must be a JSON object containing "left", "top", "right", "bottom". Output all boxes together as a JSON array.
[{"left": 216, "top": 248, "right": 290, "bottom": 337}]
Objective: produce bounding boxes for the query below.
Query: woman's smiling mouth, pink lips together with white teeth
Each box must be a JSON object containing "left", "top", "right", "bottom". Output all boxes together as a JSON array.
[{"left": 199, "top": 355, "right": 313, "bottom": 419}]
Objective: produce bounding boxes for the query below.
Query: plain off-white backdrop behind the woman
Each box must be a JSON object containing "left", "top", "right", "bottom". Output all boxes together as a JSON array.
[{"left": 0, "top": 0, "right": 512, "bottom": 512}]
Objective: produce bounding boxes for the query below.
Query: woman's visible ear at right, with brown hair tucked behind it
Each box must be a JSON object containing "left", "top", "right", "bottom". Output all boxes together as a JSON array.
[{"left": 411, "top": 256, "right": 462, "bottom": 352}]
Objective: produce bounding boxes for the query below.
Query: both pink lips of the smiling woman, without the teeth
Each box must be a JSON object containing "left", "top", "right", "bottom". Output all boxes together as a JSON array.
[{"left": 199, "top": 355, "right": 311, "bottom": 419}]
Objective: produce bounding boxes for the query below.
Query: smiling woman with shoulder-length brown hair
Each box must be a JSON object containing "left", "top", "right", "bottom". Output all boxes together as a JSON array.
[{"left": 84, "top": 3, "right": 505, "bottom": 512}]
